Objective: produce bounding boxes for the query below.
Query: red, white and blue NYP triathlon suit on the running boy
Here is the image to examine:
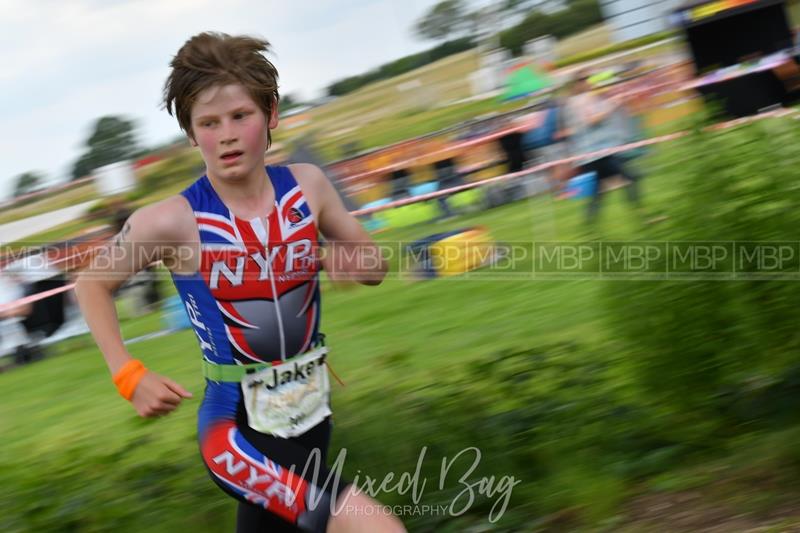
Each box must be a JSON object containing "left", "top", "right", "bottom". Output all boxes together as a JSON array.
[{"left": 173, "top": 166, "right": 341, "bottom": 531}]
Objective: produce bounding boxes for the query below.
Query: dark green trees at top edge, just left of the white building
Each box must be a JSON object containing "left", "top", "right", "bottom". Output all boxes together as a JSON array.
[{"left": 500, "top": 0, "right": 603, "bottom": 55}]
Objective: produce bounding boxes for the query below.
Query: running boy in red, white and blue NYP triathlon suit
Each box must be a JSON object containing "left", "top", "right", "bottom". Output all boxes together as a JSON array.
[{"left": 76, "top": 33, "right": 404, "bottom": 532}]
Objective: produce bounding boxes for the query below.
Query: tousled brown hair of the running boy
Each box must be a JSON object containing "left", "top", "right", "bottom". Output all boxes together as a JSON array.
[{"left": 164, "top": 32, "right": 280, "bottom": 146}]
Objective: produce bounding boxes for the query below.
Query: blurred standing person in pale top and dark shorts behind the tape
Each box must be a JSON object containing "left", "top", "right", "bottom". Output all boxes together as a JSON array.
[{"left": 564, "top": 71, "right": 641, "bottom": 224}]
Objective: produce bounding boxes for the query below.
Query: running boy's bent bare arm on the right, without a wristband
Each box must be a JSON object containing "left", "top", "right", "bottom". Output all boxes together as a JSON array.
[{"left": 291, "top": 164, "right": 388, "bottom": 285}]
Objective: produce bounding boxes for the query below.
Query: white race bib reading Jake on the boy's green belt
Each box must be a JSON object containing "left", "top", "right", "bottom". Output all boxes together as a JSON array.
[{"left": 241, "top": 346, "right": 331, "bottom": 439}]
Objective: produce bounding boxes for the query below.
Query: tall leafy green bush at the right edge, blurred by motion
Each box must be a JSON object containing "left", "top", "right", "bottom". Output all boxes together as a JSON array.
[{"left": 606, "top": 112, "right": 800, "bottom": 436}]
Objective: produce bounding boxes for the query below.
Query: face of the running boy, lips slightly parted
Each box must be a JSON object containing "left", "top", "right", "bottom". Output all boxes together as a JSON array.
[{"left": 189, "top": 85, "right": 278, "bottom": 181}]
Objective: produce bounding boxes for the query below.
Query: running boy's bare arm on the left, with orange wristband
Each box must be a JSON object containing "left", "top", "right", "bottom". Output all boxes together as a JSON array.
[{"left": 75, "top": 195, "right": 191, "bottom": 417}]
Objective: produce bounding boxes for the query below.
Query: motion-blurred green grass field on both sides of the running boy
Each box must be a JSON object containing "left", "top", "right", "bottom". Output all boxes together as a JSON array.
[{"left": 0, "top": 128, "right": 796, "bottom": 531}]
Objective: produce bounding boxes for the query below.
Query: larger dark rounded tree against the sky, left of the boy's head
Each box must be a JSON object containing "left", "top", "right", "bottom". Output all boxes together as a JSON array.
[{"left": 72, "top": 116, "right": 141, "bottom": 179}]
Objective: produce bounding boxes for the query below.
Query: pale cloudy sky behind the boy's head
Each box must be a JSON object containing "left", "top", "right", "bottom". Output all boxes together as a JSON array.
[{"left": 0, "top": 0, "right": 488, "bottom": 198}]
